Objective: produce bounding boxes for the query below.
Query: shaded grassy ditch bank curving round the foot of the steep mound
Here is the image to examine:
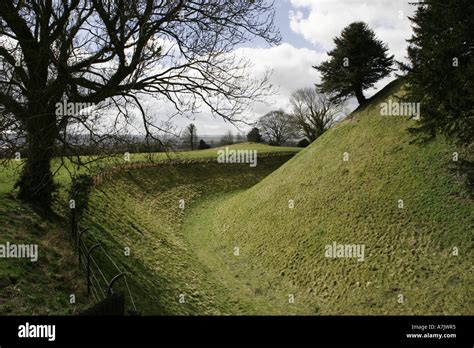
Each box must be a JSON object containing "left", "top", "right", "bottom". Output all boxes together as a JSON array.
[{"left": 83, "top": 155, "right": 291, "bottom": 315}]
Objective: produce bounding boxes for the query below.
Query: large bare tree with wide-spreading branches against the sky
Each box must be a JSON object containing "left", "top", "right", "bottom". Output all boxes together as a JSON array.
[{"left": 0, "top": 0, "right": 279, "bottom": 206}]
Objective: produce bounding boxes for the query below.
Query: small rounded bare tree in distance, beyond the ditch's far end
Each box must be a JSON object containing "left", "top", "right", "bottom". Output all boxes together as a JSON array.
[{"left": 258, "top": 110, "right": 296, "bottom": 145}]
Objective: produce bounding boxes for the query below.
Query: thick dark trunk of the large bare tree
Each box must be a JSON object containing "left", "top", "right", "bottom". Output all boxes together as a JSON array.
[{"left": 16, "top": 114, "right": 57, "bottom": 211}]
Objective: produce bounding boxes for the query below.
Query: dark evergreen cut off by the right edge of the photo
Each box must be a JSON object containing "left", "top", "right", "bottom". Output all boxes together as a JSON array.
[{"left": 404, "top": 0, "right": 474, "bottom": 145}]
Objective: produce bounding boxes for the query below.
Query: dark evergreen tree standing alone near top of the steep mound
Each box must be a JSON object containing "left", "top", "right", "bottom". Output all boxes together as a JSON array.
[{"left": 314, "top": 22, "right": 393, "bottom": 104}]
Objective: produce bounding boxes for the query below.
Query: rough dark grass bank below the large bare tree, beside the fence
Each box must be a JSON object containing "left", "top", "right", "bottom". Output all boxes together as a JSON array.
[{"left": 0, "top": 195, "right": 91, "bottom": 315}]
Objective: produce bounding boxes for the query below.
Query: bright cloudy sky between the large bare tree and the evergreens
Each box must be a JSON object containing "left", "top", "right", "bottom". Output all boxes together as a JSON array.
[{"left": 156, "top": 0, "right": 414, "bottom": 135}]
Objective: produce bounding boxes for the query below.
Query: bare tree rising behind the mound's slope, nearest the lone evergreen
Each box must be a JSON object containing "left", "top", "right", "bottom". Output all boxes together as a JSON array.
[{"left": 290, "top": 88, "right": 342, "bottom": 142}]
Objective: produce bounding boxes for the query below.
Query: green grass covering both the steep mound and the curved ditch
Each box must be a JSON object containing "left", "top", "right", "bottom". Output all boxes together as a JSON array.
[{"left": 0, "top": 81, "right": 474, "bottom": 315}]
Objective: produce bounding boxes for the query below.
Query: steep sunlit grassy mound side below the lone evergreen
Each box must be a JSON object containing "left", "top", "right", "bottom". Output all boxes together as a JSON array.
[{"left": 183, "top": 82, "right": 474, "bottom": 315}]
